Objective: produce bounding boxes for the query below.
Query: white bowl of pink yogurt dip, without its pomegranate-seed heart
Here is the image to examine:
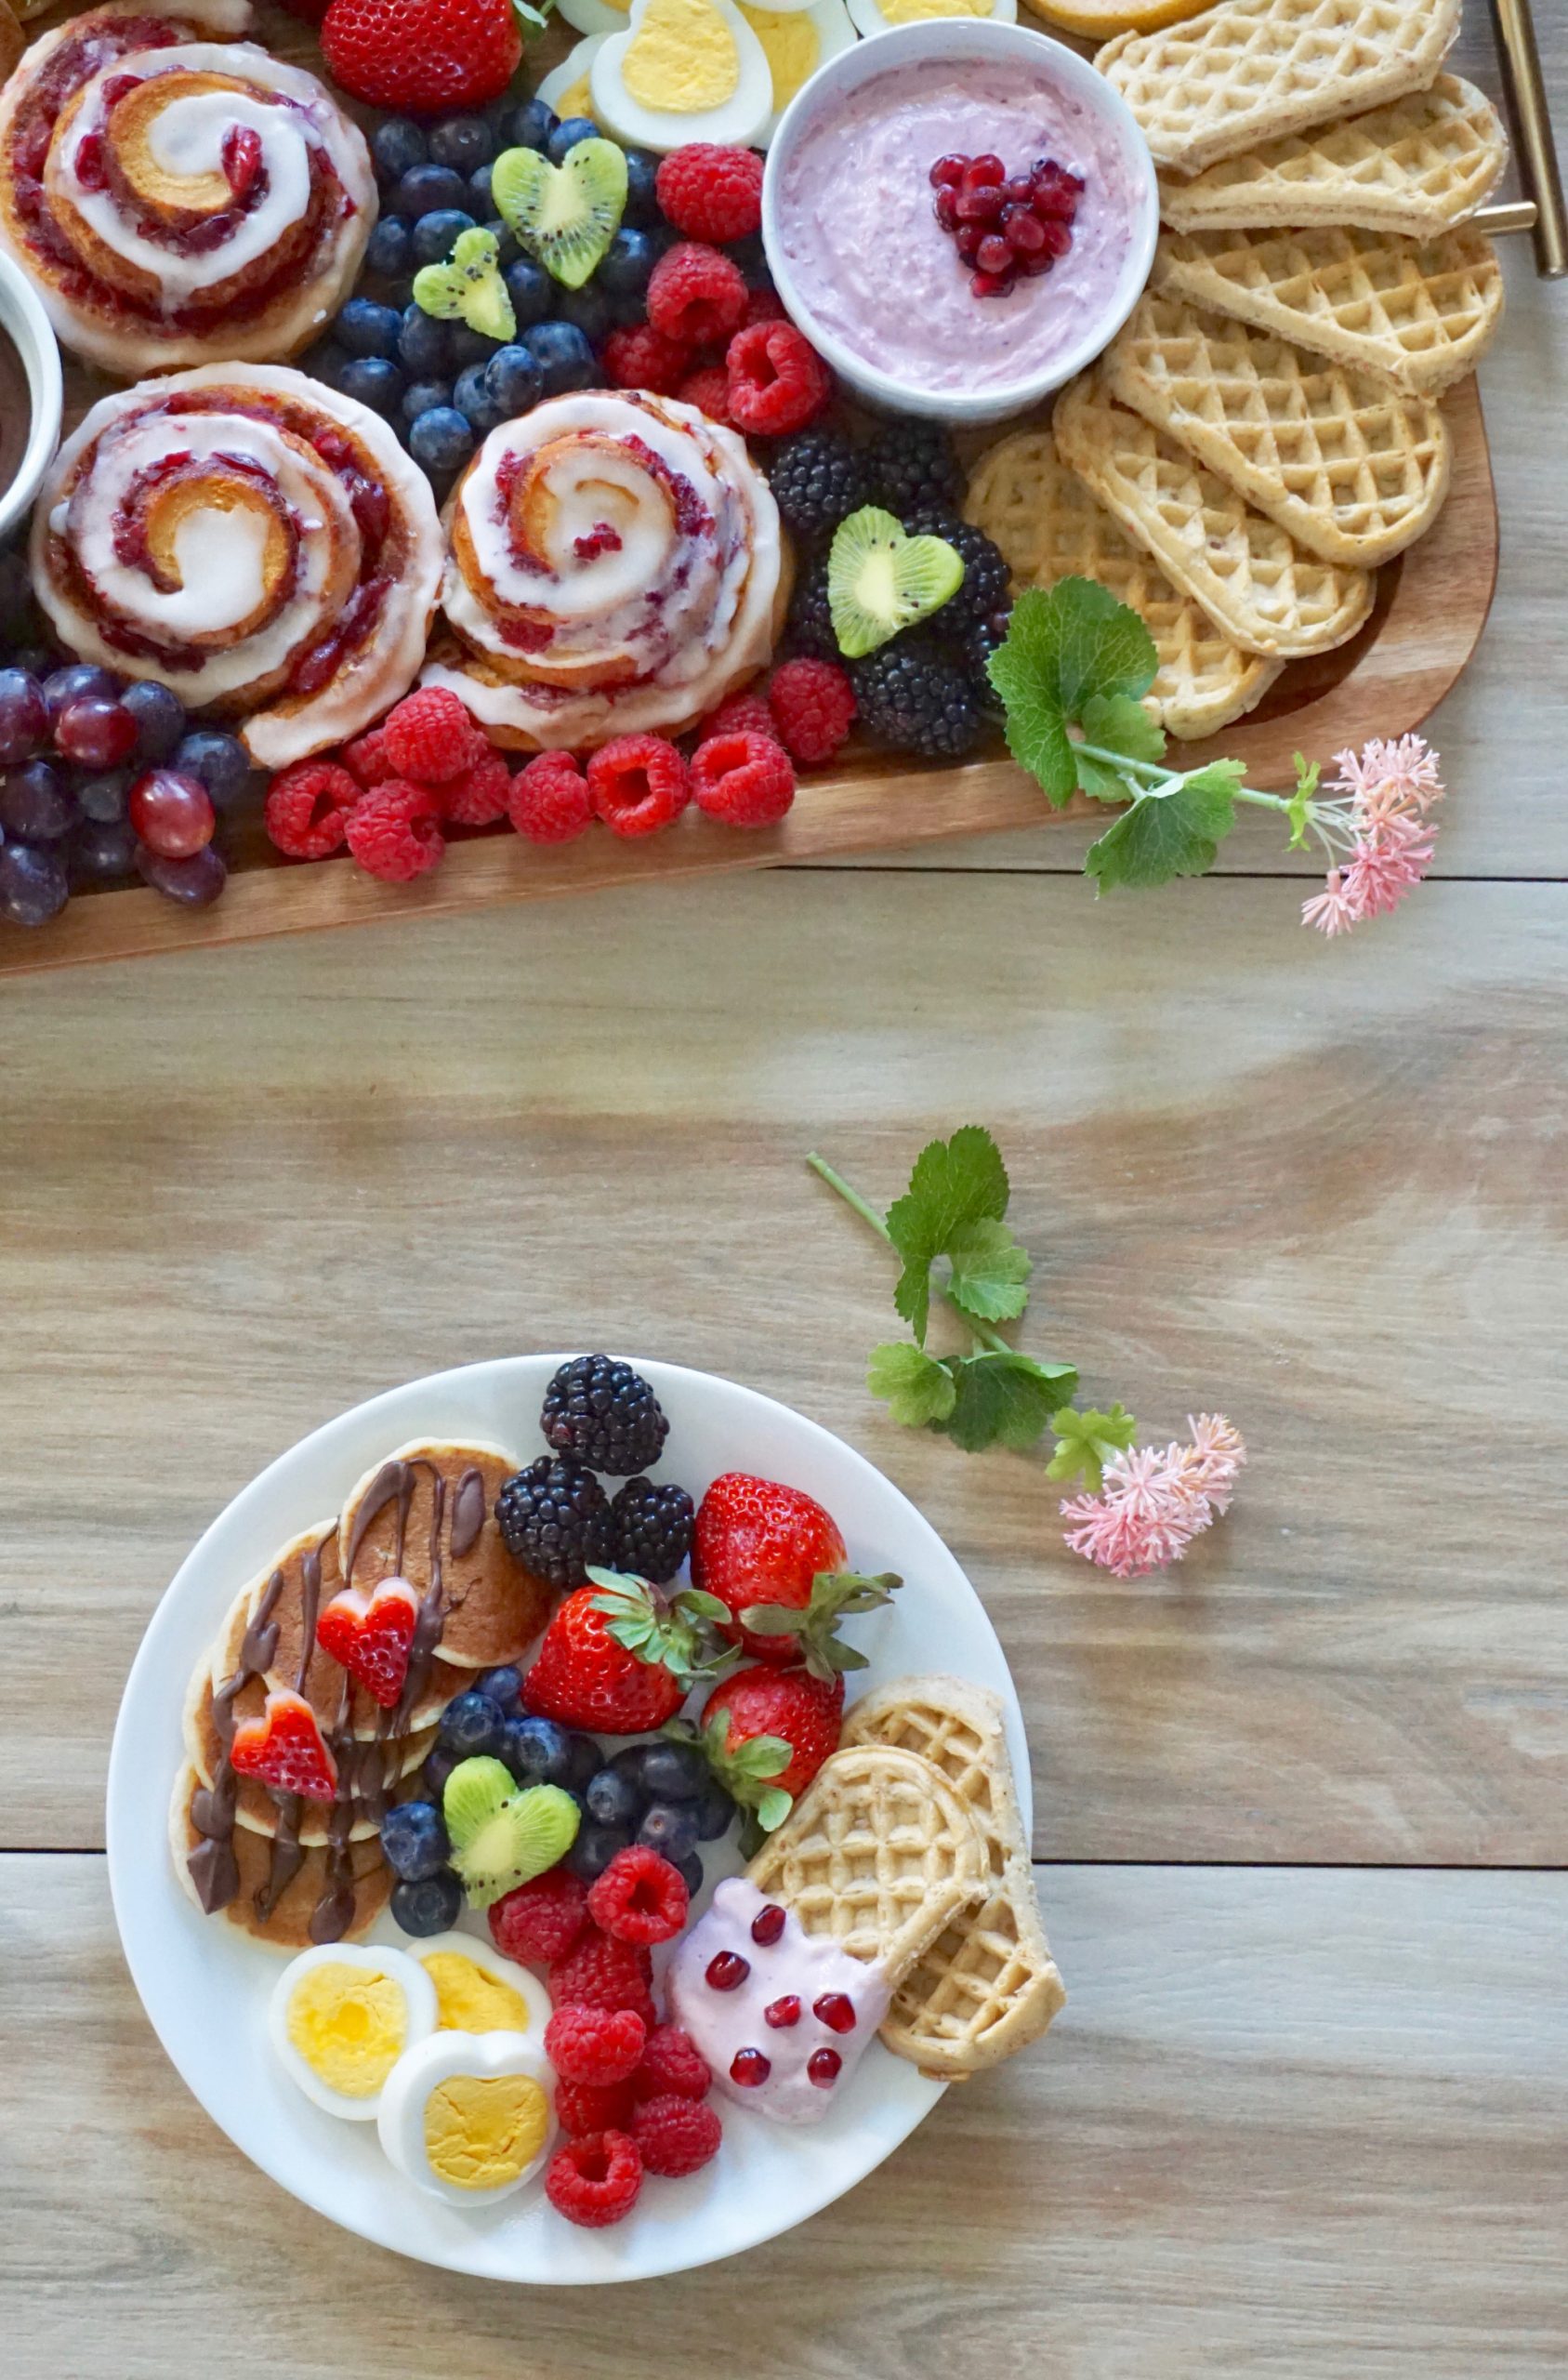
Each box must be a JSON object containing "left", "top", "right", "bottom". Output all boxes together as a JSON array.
[{"left": 761, "top": 17, "right": 1159, "bottom": 421}]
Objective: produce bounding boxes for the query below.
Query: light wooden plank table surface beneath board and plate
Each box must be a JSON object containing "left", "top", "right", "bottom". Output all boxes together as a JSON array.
[{"left": 0, "top": 0, "right": 1568, "bottom": 2380}]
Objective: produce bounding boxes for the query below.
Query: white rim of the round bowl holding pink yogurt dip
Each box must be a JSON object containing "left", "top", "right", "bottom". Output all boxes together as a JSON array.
[{"left": 761, "top": 17, "right": 1159, "bottom": 424}]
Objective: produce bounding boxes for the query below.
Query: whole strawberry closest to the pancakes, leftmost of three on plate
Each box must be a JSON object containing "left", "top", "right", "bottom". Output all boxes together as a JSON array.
[{"left": 523, "top": 1568, "right": 714, "bottom": 1735}]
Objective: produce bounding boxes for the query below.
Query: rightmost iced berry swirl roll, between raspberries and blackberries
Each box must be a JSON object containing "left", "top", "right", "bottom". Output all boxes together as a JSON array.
[{"left": 424, "top": 390, "right": 785, "bottom": 752}]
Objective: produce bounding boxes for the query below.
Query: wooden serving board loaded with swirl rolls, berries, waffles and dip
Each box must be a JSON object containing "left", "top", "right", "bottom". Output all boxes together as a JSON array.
[{"left": 0, "top": 0, "right": 1509, "bottom": 971}]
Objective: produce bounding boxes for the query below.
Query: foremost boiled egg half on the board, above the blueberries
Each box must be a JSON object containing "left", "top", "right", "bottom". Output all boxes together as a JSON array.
[{"left": 590, "top": 0, "right": 773, "bottom": 154}]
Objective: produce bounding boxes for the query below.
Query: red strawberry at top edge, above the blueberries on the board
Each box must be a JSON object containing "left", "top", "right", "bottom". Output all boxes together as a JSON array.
[{"left": 322, "top": 0, "right": 523, "bottom": 116}]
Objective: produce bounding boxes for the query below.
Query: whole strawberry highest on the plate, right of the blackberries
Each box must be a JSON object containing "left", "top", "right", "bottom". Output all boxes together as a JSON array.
[{"left": 692, "top": 1471, "right": 902, "bottom": 1678}]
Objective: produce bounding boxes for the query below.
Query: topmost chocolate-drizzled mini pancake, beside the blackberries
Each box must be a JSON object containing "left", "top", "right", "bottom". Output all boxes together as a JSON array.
[{"left": 338, "top": 1437, "right": 552, "bottom": 1701}]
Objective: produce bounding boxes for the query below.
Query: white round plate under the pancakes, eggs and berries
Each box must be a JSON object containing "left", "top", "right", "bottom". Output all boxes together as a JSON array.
[{"left": 107, "top": 1355, "right": 1030, "bottom": 2282}]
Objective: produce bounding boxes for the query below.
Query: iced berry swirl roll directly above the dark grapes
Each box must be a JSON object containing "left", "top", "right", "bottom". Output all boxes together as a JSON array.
[{"left": 31, "top": 364, "right": 442, "bottom": 769}]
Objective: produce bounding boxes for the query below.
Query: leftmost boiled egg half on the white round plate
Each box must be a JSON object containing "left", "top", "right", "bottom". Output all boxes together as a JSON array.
[{"left": 269, "top": 1942, "right": 438, "bottom": 2123}]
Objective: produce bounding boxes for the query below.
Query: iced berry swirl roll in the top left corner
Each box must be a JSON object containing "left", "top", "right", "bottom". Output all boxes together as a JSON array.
[{"left": 0, "top": 0, "right": 376, "bottom": 376}]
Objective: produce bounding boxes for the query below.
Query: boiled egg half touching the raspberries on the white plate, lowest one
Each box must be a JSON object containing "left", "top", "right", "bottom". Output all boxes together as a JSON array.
[{"left": 376, "top": 2032, "right": 554, "bottom": 2206}]
